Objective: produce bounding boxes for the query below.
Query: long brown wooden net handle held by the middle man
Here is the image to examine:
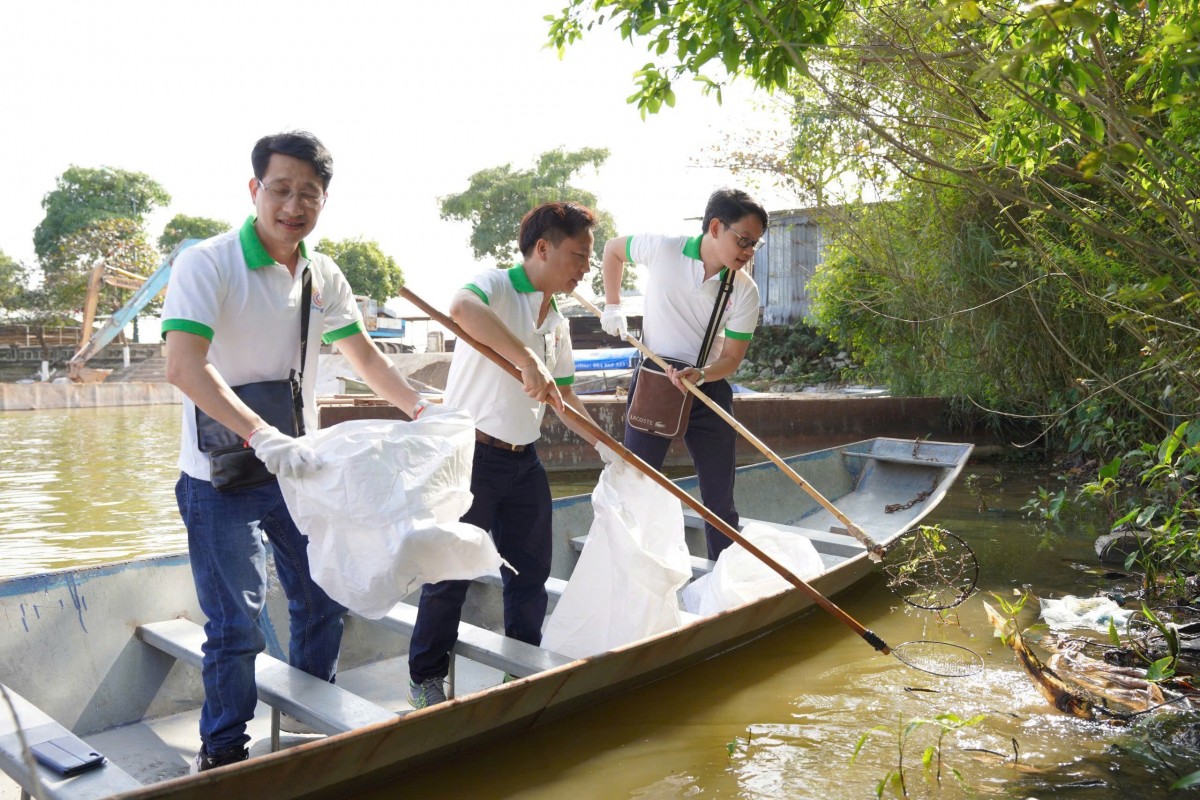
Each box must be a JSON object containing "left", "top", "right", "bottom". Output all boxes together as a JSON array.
[{"left": 400, "top": 288, "right": 892, "bottom": 654}]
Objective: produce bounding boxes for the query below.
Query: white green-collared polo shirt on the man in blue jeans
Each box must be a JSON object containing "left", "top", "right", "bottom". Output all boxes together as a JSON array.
[{"left": 162, "top": 216, "right": 364, "bottom": 481}]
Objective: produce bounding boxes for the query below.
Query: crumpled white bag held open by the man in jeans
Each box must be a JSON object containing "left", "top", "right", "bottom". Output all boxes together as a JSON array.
[{"left": 280, "top": 413, "right": 502, "bottom": 619}]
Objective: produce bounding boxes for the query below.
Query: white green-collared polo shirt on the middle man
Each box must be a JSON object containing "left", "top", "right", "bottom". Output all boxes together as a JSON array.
[{"left": 445, "top": 265, "right": 575, "bottom": 445}]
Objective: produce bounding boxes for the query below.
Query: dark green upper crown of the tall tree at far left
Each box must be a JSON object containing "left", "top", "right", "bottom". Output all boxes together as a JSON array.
[{"left": 34, "top": 164, "right": 170, "bottom": 266}]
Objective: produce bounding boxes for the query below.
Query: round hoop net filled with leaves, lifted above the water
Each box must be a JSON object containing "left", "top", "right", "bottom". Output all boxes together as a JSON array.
[{"left": 882, "top": 525, "right": 979, "bottom": 610}]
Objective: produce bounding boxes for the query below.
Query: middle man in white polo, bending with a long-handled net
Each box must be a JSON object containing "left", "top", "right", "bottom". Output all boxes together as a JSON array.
[{"left": 408, "top": 203, "right": 612, "bottom": 709}]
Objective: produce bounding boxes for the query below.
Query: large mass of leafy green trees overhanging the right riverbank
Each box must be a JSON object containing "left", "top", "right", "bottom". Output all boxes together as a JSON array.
[{"left": 550, "top": 0, "right": 1200, "bottom": 460}]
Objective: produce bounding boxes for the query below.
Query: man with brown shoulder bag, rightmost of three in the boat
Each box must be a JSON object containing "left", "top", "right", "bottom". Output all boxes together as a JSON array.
[{"left": 600, "top": 188, "right": 767, "bottom": 559}]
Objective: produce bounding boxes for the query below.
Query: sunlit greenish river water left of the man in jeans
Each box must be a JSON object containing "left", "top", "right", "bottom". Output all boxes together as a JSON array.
[{"left": 0, "top": 405, "right": 187, "bottom": 577}]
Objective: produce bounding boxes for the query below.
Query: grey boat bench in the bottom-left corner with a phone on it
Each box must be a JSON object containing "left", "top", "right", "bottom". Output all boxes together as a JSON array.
[{"left": 0, "top": 686, "right": 142, "bottom": 800}]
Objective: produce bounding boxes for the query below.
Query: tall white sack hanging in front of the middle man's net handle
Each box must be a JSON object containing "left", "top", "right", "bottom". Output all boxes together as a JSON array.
[{"left": 542, "top": 462, "right": 691, "bottom": 658}]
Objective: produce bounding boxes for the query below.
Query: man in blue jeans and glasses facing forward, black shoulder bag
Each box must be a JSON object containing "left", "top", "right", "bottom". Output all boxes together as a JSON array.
[{"left": 162, "top": 132, "right": 425, "bottom": 770}]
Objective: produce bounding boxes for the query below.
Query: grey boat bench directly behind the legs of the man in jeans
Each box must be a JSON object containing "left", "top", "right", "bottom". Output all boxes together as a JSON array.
[{"left": 137, "top": 619, "right": 396, "bottom": 748}]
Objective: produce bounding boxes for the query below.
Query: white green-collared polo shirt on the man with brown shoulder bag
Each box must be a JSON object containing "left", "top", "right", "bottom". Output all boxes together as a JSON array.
[{"left": 625, "top": 234, "right": 758, "bottom": 366}]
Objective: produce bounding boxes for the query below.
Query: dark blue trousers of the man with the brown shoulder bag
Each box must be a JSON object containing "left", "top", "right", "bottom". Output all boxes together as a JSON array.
[{"left": 625, "top": 371, "right": 739, "bottom": 560}]
